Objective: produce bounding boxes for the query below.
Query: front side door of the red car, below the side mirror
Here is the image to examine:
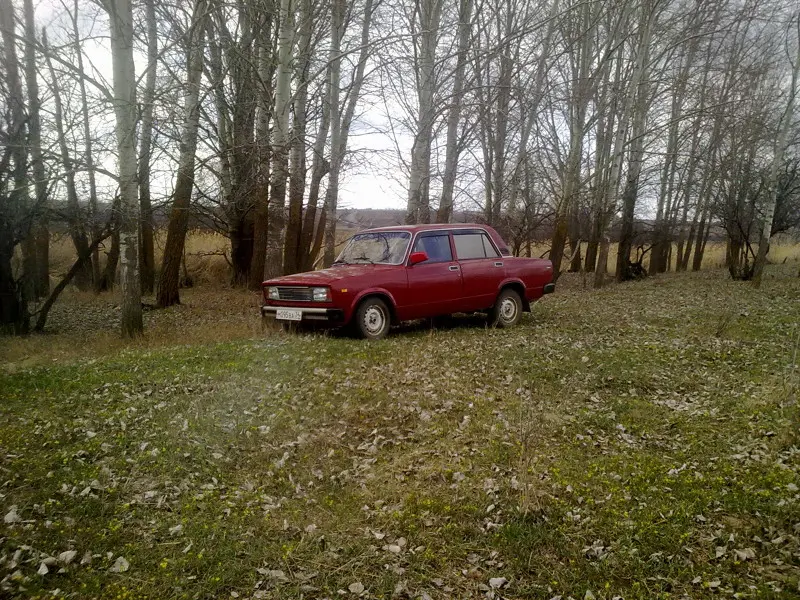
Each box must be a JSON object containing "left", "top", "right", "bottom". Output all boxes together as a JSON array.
[{"left": 398, "top": 231, "right": 463, "bottom": 319}]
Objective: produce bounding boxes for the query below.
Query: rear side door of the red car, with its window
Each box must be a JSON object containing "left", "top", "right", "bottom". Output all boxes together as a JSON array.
[{"left": 453, "top": 229, "right": 505, "bottom": 311}]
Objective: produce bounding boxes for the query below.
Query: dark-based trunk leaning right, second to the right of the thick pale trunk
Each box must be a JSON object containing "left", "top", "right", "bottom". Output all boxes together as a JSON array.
[{"left": 156, "top": 0, "right": 208, "bottom": 308}]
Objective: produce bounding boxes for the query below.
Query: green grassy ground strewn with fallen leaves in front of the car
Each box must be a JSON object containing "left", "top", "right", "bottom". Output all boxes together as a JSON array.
[{"left": 0, "top": 265, "right": 800, "bottom": 600}]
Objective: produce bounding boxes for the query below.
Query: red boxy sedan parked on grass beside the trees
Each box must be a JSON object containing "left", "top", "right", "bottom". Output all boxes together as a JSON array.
[{"left": 261, "top": 224, "right": 555, "bottom": 339}]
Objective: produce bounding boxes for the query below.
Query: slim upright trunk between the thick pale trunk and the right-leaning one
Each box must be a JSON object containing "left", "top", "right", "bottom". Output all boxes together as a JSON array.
[{"left": 138, "top": 0, "right": 158, "bottom": 294}]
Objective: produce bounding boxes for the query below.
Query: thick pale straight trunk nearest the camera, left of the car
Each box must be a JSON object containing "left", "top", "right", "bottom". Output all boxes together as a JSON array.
[{"left": 106, "top": 0, "right": 144, "bottom": 337}]
